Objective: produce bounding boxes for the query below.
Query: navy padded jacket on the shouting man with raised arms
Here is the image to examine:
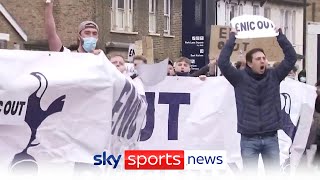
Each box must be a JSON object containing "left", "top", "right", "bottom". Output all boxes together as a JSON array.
[{"left": 218, "top": 32, "right": 297, "bottom": 135}]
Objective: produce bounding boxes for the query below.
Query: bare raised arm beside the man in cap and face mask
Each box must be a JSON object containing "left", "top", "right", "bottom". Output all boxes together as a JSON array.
[{"left": 45, "top": 0, "right": 62, "bottom": 51}]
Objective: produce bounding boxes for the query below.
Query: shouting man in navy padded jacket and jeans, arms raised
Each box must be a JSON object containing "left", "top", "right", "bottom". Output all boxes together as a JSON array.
[{"left": 218, "top": 29, "right": 297, "bottom": 173}]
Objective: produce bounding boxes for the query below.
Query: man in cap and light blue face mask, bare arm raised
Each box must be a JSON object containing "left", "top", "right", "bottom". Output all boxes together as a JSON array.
[{"left": 45, "top": 0, "right": 101, "bottom": 54}]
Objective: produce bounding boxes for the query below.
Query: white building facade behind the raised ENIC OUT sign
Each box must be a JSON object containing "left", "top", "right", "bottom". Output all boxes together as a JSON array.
[{"left": 217, "top": 0, "right": 303, "bottom": 54}]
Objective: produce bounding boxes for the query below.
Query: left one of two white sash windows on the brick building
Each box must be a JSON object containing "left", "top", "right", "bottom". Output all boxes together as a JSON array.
[{"left": 111, "top": 0, "right": 133, "bottom": 32}]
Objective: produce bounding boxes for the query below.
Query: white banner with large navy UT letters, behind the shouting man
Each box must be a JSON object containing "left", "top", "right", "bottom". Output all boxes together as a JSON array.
[{"left": 140, "top": 77, "right": 316, "bottom": 173}]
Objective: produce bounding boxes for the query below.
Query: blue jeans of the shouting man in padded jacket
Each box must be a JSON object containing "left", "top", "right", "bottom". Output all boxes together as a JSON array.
[{"left": 240, "top": 132, "right": 280, "bottom": 174}]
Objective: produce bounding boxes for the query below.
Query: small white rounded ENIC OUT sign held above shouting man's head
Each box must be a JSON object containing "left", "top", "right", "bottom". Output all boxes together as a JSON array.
[{"left": 231, "top": 15, "right": 279, "bottom": 39}]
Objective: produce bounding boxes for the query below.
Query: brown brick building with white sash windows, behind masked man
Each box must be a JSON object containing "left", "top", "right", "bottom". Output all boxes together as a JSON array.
[{"left": 0, "top": 0, "right": 182, "bottom": 59}]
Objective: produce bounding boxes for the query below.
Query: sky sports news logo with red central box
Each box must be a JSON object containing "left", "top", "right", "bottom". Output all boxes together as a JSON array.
[{"left": 93, "top": 150, "right": 227, "bottom": 170}]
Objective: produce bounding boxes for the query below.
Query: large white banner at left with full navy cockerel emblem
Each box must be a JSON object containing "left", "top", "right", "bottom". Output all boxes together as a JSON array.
[{"left": 0, "top": 50, "right": 146, "bottom": 174}]
